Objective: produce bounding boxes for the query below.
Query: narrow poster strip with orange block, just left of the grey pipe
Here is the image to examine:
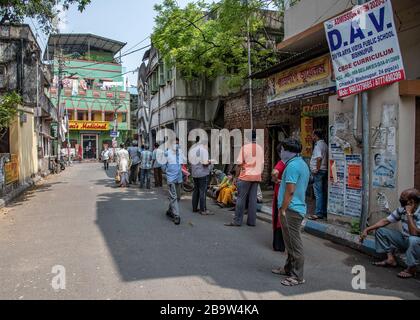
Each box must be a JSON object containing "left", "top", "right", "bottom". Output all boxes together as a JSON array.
[{"left": 345, "top": 154, "right": 363, "bottom": 217}]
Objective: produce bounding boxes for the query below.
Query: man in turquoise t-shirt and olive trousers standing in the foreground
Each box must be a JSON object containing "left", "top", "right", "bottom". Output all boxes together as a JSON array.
[{"left": 273, "top": 138, "right": 310, "bottom": 287}]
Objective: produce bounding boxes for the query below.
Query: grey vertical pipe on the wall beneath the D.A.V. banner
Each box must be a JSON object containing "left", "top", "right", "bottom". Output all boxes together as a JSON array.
[{"left": 358, "top": 0, "right": 370, "bottom": 230}]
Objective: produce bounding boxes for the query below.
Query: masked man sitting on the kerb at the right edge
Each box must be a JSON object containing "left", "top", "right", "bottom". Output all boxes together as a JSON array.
[{"left": 360, "top": 189, "right": 420, "bottom": 279}]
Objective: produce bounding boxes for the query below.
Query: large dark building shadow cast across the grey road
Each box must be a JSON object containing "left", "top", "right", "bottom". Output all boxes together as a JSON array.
[{"left": 96, "top": 165, "right": 420, "bottom": 296}]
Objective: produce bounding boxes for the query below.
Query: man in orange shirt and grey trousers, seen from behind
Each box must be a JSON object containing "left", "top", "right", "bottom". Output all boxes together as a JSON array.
[{"left": 225, "top": 131, "right": 264, "bottom": 227}]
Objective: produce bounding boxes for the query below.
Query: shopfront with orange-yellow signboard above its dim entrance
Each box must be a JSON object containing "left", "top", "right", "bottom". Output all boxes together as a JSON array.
[{"left": 267, "top": 55, "right": 335, "bottom": 163}]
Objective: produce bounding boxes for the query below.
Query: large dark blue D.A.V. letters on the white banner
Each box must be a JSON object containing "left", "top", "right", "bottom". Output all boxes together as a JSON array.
[{"left": 327, "top": 7, "right": 393, "bottom": 52}]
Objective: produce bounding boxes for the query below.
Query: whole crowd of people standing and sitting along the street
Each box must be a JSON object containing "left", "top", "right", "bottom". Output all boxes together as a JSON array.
[{"left": 103, "top": 130, "right": 420, "bottom": 287}]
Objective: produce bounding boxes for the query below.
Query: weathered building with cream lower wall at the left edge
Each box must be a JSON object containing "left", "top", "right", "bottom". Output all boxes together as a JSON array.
[{"left": 0, "top": 24, "right": 57, "bottom": 195}]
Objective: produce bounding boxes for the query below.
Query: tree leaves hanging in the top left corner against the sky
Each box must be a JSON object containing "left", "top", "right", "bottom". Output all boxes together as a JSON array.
[{"left": 0, "top": 0, "right": 91, "bottom": 33}]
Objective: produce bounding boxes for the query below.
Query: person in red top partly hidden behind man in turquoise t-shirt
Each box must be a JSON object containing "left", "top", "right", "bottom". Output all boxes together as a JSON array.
[{"left": 271, "top": 144, "right": 286, "bottom": 252}]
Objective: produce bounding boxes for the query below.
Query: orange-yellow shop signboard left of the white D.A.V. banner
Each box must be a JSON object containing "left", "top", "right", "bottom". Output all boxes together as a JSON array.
[{"left": 268, "top": 55, "right": 336, "bottom": 105}]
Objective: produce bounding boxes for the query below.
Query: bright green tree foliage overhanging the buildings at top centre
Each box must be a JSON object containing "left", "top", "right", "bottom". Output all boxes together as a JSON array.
[{"left": 152, "top": 0, "right": 282, "bottom": 86}]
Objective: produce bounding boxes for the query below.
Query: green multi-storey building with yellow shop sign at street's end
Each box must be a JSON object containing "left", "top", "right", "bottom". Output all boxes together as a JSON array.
[{"left": 44, "top": 34, "right": 130, "bottom": 159}]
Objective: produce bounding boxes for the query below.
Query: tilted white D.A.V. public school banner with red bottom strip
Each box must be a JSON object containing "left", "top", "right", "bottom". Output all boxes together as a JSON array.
[{"left": 325, "top": 0, "right": 405, "bottom": 98}]
